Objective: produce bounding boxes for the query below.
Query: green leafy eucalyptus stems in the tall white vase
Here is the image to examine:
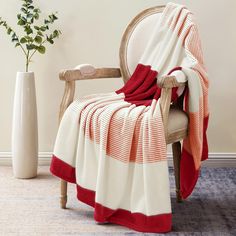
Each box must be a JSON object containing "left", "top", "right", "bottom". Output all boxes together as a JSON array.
[{"left": 0, "top": 0, "right": 61, "bottom": 72}]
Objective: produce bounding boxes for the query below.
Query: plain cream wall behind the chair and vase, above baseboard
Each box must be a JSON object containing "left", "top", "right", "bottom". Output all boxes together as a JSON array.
[{"left": 0, "top": 0, "right": 236, "bottom": 157}]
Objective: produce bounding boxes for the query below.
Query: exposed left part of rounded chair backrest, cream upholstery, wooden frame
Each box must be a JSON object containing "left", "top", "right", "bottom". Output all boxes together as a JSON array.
[{"left": 120, "top": 6, "right": 165, "bottom": 83}]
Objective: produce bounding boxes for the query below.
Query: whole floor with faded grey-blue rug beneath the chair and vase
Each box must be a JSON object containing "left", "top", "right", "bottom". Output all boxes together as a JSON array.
[{"left": 0, "top": 166, "right": 236, "bottom": 236}]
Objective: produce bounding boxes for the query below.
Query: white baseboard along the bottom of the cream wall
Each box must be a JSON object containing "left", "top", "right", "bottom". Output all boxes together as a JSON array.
[{"left": 0, "top": 152, "right": 236, "bottom": 167}]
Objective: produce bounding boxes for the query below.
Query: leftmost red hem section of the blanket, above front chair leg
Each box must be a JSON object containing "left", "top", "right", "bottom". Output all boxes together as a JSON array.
[{"left": 50, "top": 155, "right": 76, "bottom": 184}]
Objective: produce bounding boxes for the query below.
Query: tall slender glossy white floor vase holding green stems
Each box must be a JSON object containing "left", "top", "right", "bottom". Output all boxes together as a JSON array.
[{"left": 12, "top": 72, "right": 38, "bottom": 179}]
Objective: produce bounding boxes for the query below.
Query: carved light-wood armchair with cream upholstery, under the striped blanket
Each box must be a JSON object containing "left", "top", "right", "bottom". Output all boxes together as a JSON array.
[{"left": 59, "top": 6, "right": 188, "bottom": 208}]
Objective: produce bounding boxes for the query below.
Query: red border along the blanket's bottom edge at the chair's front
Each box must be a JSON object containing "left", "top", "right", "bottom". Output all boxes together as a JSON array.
[{"left": 50, "top": 156, "right": 172, "bottom": 233}]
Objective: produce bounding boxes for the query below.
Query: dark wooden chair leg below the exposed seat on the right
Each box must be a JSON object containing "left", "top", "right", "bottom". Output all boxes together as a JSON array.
[{"left": 172, "top": 142, "right": 182, "bottom": 202}]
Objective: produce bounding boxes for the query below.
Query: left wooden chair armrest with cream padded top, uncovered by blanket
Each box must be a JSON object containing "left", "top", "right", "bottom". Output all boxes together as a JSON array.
[{"left": 59, "top": 64, "right": 121, "bottom": 81}]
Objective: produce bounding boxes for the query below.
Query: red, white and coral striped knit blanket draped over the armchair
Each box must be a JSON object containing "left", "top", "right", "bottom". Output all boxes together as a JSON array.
[{"left": 51, "top": 3, "right": 208, "bottom": 232}]
